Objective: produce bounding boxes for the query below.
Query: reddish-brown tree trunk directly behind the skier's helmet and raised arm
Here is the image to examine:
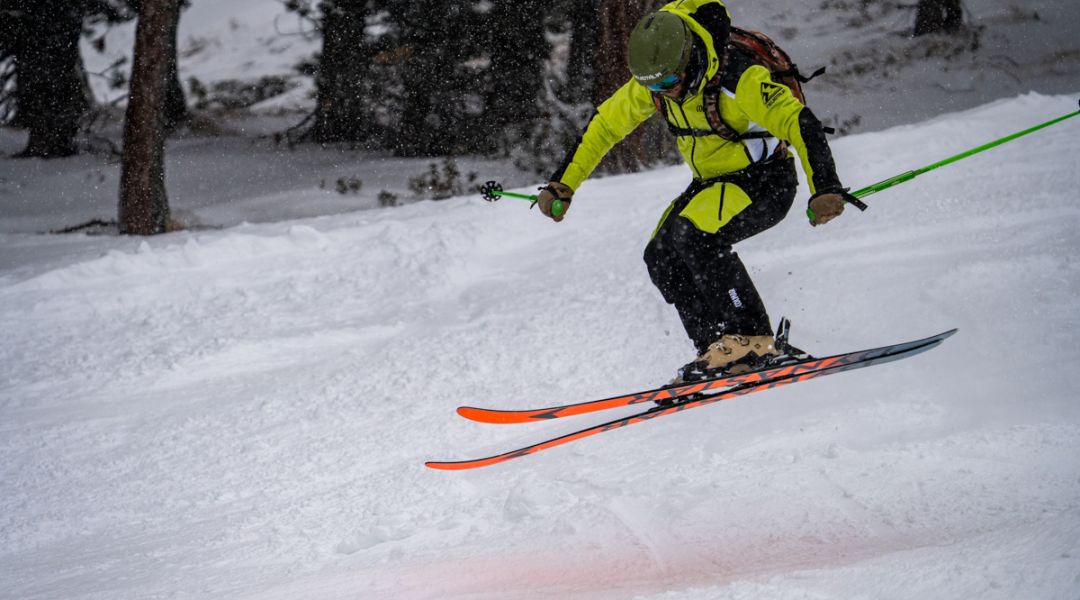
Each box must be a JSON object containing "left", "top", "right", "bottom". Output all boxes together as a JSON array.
[{"left": 593, "top": 0, "right": 653, "bottom": 173}]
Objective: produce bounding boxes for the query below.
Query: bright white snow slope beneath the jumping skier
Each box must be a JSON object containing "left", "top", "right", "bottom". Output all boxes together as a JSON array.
[{"left": 0, "top": 94, "right": 1080, "bottom": 600}]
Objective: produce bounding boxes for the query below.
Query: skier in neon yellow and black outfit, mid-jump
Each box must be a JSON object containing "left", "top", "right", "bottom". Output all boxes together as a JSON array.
[{"left": 538, "top": 0, "right": 858, "bottom": 382}]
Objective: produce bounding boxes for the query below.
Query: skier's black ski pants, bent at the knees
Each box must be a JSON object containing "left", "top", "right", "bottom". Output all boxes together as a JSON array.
[{"left": 645, "top": 159, "right": 798, "bottom": 353}]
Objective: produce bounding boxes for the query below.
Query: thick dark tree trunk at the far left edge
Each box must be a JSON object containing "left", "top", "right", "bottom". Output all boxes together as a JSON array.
[{"left": 12, "top": 0, "right": 91, "bottom": 159}]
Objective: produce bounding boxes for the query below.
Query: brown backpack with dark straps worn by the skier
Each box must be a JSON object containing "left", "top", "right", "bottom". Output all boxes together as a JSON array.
[{"left": 653, "top": 27, "right": 834, "bottom": 141}]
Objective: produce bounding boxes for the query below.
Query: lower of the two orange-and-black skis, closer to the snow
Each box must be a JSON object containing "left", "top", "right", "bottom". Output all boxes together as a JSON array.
[{"left": 424, "top": 329, "right": 956, "bottom": 471}]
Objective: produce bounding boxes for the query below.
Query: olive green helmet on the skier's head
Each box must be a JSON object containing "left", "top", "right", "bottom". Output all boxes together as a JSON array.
[{"left": 629, "top": 11, "right": 693, "bottom": 86}]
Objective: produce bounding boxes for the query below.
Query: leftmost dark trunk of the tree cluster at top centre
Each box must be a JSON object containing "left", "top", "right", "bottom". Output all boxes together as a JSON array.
[{"left": 311, "top": 0, "right": 372, "bottom": 142}]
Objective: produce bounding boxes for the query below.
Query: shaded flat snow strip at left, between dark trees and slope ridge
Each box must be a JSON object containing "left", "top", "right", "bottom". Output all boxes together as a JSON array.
[{"left": 0, "top": 129, "right": 521, "bottom": 234}]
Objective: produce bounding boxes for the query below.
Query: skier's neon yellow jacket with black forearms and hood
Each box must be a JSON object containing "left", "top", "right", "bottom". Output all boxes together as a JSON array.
[{"left": 552, "top": 0, "right": 840, "bottom": 201}]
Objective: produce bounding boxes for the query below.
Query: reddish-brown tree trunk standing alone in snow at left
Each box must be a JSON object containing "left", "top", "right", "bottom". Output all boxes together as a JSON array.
[{"left": 119, "top": 0, "right": 179, "bottom": 235}]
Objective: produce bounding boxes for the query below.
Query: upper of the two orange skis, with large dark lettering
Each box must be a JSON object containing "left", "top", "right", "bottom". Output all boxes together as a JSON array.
[{"left": 457, "top": 330, "right": 955, "bottom": 425}]
